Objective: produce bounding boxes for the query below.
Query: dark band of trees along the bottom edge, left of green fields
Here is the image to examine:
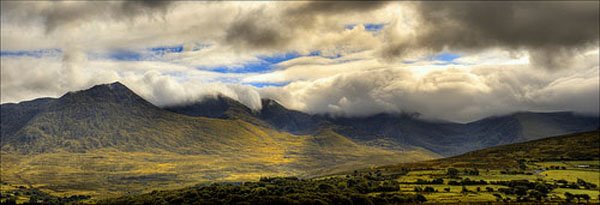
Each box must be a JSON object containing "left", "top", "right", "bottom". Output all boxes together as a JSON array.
[{"left": 100, "top": 173, "right": 429, "bottom": 204}]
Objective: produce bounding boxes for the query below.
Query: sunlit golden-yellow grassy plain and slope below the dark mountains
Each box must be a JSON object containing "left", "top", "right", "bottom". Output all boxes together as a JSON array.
[{"left": 0, "top": 129, "right": 437, "bottom": 201}]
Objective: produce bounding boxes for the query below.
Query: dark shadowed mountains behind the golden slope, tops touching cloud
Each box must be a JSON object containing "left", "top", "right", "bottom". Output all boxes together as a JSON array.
[{"left": 166, "top": 97, "right": 600, "bottom": 156}]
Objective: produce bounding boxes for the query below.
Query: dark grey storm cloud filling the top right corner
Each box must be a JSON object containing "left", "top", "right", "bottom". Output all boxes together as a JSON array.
[{"left": 384, "top": 1, "right": 599, "bottom": 68}]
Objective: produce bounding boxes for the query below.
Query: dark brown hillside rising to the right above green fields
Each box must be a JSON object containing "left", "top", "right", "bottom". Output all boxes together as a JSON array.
[{"left": 383, "top": 130, "right": 600, "bottom": 171}]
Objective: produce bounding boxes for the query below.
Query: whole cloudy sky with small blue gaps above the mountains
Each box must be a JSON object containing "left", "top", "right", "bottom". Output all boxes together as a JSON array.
[{"left": 0, "top": 1, "right": 600, "bottom": 122}]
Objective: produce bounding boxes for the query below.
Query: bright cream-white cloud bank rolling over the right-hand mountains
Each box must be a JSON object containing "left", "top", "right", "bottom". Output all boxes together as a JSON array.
[{"left": 260, "top": 50, "right": 600, "bottom": 122}]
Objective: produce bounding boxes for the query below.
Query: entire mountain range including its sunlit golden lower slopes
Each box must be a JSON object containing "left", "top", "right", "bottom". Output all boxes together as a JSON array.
[{"left": 0, "top": 82, "right": 599, "bottom": 195}]
